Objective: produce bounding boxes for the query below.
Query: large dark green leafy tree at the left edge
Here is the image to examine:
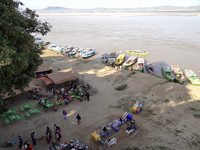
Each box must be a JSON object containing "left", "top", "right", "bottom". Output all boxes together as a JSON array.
[{"left": 0, "top": 0, "right": 51, "bottom": 110}]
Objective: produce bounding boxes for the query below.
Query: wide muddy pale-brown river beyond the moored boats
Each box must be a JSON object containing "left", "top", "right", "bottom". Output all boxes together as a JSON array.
[{"left": 40, "top": 15, "right": 200, "bottom": 76}]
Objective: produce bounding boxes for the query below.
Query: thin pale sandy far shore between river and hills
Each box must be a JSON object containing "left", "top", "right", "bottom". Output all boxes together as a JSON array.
[{"left": 38, "top": 12, "right": 200, "bottom": 16}]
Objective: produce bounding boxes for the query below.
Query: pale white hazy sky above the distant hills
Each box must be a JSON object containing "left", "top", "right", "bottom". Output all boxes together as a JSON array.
[{"left": 20, "top": 0, "right": 200, "bottom": 9}]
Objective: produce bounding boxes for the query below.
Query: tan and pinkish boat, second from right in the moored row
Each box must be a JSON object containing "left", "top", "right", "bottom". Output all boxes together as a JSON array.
[{"left": 171, "top": 65, "right": 185, "bottom": 84}]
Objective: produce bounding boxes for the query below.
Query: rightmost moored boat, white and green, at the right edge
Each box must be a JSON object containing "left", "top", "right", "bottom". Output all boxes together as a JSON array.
[{"left": 183, "top": 69, "right": 200, "bottom": 85}]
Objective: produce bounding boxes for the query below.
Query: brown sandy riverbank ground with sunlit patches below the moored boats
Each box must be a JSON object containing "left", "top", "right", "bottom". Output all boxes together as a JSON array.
[{"left": 0, "top": 50, "right": 200, "bottom": 150}]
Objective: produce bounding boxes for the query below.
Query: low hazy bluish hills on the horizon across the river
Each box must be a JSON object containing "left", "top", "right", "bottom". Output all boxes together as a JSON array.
[{"left": 36, "top": 5, "right": 200, "bottom": 13}]
